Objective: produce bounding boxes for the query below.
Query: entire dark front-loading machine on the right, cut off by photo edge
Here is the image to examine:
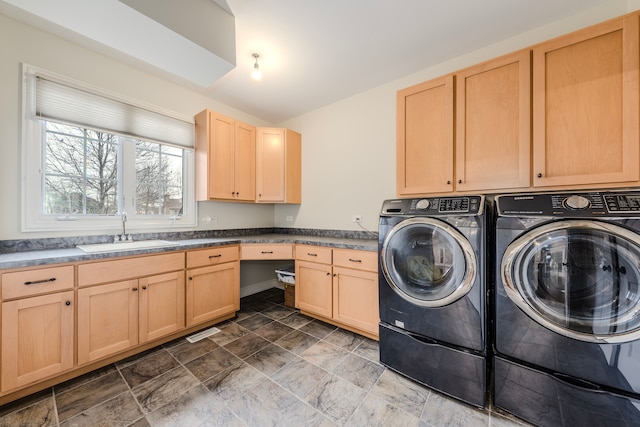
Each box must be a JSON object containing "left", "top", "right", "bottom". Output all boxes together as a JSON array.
[{"left": 493, "top": 191, "right": 640, "bottom": 427}]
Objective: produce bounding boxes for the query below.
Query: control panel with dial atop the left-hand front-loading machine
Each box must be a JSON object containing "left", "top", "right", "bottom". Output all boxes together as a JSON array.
[{"left": 382, "top": 196, "right": 484, "bottom": 216}]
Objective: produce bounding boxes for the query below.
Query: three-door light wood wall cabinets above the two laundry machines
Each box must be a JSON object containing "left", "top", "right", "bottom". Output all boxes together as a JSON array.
[{"left": 396, "top": 12, "right": 640, "bottom": 197}]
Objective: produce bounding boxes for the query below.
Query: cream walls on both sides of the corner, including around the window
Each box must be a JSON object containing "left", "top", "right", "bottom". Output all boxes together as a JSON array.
[{"left": 0, "top": 0, "right": 640, "bottom": 239}]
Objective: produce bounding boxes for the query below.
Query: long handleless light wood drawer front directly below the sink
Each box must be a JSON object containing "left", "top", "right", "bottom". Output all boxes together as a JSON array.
[{"left": 78, "top": 252, "right": 184, "bottom": 286}]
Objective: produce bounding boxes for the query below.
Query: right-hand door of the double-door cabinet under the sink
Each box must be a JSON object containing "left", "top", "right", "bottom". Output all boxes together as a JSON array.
[{"left": 138, "top": 271, "right": 185, "bottom": 343}]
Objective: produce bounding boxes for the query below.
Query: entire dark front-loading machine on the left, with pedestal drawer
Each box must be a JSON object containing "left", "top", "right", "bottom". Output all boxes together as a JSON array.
[{"left": 378, "top": 196, "right": 491, "bottom": 407}]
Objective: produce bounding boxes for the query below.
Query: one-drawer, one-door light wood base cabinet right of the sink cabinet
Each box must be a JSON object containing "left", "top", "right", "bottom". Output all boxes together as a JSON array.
[{"left": 186, "top": 246, "right": 240, "bottom": 326}]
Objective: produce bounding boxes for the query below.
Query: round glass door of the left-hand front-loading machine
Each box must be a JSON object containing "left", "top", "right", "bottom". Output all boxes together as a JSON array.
[{"left": 380, "top": 218, "right": 477, "bottom": 307}]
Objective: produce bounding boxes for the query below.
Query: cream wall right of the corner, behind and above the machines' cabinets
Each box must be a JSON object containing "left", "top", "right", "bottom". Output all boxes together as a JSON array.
[{"left": 274, "top": 0, "right": 640, "bottom": 231}]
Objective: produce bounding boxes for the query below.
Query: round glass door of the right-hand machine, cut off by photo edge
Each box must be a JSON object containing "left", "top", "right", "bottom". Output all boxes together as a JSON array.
[{"left": 501, "top": 220, "right": 640, "bottom": 343}]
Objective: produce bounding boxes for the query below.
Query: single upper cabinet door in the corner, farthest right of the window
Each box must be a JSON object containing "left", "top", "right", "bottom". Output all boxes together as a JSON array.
[{"left": 256, "top": 128, "right": 285, "bottom": 202}]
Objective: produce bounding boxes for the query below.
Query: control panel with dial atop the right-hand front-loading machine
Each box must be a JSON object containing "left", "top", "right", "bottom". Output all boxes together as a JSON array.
[{"left": 496, "top": 192, "right": 640, "bottom": 218}]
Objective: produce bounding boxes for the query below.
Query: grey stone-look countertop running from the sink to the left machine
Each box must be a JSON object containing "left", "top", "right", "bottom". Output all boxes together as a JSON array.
[{"left": 0, "top": 233, "right": 378, "bottom": 269}]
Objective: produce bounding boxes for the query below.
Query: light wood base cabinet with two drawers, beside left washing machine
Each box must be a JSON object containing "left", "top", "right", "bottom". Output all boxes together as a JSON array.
[{"left": 296, "top": 245, "right": 379, "bottom": 339}]
